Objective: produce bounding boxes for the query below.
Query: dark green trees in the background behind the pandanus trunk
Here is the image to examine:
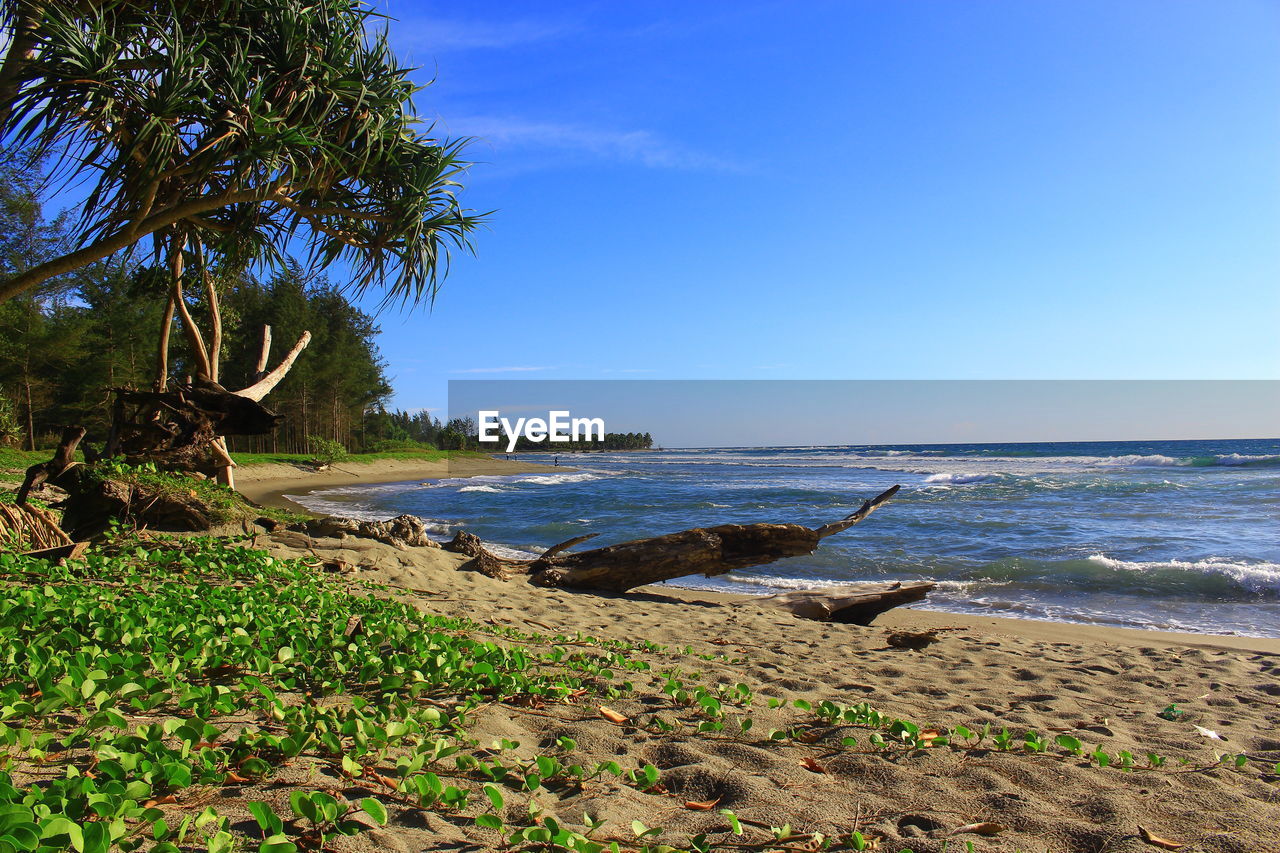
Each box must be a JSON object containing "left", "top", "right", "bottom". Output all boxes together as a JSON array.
[{"left": 0, "top": 151, "right": 390, "bottom": 453}]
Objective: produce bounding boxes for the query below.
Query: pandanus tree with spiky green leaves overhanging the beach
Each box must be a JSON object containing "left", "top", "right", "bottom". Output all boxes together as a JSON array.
[{"left": 0, "top": 0, "right": 483, "bottom": 479}]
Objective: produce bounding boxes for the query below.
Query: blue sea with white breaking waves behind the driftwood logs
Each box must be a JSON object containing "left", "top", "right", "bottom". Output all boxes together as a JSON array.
[{"left": 288, "top": 439, "right": 1280, "bottom": 637}]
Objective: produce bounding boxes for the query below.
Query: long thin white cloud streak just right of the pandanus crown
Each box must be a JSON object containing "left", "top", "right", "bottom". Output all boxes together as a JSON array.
[{"left": 442, "top": 115, "right": 741, "bottom": 172}]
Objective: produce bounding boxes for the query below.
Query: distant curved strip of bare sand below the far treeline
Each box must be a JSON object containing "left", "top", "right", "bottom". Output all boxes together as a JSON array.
[{"left": 236, "top": 456, "right": 565, "bottom": 515}]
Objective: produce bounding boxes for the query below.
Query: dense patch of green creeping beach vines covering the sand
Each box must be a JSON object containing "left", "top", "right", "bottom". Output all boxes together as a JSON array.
[{"left": 0, "top": 539, "right": 599, "bottom": 853}]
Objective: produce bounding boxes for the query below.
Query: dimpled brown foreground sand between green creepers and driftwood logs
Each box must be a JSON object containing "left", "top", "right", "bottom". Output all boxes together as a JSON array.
[{"left": 241, "top": 533, "right": 1280, "bottom": 853}]
